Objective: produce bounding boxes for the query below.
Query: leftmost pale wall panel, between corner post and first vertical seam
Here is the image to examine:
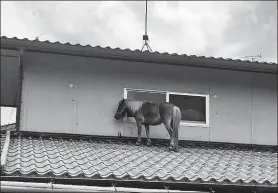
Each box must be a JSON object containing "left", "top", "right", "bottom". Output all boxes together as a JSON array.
[{"left": 22, "top": 53, "right": 75, "bottom": 133}]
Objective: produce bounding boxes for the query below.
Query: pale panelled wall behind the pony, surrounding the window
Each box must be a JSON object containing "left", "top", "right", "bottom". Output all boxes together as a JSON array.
[{"left": 20, "top": 52, "right": 277, "bottom": 145}]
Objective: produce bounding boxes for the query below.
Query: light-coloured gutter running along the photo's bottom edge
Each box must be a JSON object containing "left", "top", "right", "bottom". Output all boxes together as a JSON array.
[{"left": 1, "top": 181, "right": 207, "bottom": 193}]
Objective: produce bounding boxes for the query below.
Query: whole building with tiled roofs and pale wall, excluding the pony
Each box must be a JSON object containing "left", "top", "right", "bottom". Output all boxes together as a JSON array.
[{"left": 1, "top": 37, "right": 277, "bottom": 192}]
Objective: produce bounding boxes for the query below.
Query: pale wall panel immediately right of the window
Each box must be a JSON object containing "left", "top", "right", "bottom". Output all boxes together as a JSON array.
[{"left": 210, "top": 83, "right": 252, "bottom": 143}]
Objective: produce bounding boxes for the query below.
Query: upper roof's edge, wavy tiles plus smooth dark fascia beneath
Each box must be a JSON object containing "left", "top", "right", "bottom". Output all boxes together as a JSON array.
[{"left": 1, "top": 36, "right": 277, "bottom": 74}]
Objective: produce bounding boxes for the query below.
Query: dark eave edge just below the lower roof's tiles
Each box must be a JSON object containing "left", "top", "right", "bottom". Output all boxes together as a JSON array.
[{"left": 1, "top": 176, "right": 277, "bottom": 192}]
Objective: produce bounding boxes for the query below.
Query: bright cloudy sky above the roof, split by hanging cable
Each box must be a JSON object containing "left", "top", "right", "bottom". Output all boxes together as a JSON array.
[{"left": 1, "top": 1, "right": 277, "bottom": 125}]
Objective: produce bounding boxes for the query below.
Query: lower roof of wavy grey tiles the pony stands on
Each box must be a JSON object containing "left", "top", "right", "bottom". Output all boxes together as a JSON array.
[{"left": 1, "top": 136, "right": 277, "bottom": 186}]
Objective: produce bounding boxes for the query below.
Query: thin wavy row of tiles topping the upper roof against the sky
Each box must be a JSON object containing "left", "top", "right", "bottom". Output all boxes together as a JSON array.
[{"left": 1, "top": 36, "right": 277, "bottom": 65}]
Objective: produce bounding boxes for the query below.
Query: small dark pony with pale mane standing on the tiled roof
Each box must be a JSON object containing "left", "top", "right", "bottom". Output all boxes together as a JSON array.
[{"left": 114, "top": 99, "right": 181, "bottom": 152}]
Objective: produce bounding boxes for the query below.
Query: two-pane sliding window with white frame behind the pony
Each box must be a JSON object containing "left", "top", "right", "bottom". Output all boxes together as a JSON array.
[{"left": 124, "top": 88, "right": 209, "bottom": 127}]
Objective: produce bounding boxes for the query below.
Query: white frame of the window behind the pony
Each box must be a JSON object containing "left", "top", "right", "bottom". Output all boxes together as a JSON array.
[{"left": 123, "top": 88, "right": 210, "bottom": 127}]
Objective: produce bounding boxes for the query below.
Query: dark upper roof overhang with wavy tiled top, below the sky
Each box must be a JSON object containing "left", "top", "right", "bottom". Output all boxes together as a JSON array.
[{"left": 1, "top": 36, "right": 277, "bottom": 74}]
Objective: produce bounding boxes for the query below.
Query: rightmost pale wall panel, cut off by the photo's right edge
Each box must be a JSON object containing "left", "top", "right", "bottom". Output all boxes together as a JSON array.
[{"left": 252, "top": 75, "right": 277, "bottom": 145}]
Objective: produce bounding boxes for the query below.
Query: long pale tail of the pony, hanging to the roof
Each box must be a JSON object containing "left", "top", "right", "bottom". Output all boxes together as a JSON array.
[{"left": 172, "top": 106, "right": 181, "bottom": 151}]
